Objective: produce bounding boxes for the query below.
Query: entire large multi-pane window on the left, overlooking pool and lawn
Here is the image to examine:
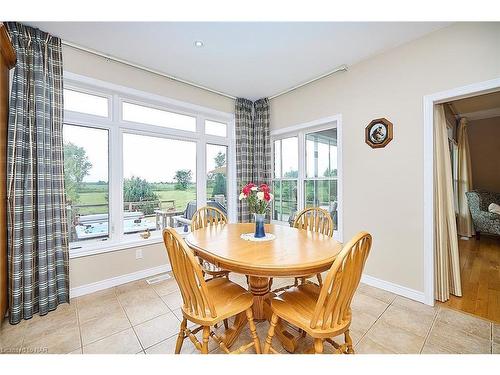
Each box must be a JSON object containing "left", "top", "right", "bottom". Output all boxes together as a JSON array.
[{"left": 64, "top": 73, "right": 232, "bottom": 257}]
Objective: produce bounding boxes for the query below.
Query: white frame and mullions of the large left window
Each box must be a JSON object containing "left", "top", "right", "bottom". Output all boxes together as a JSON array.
[{"left": 63, "top": 71, "right": 237, "bottom": 258}]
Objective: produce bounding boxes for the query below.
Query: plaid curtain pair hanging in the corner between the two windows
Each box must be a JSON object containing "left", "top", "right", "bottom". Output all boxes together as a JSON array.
[{"left": 235, "top": 98, "right": 271, "bottom": 223}]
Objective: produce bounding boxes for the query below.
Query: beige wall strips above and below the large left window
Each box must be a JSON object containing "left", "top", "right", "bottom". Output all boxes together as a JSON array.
[{"left": 63, "top": 46, "right": 234, "bottom": 288}]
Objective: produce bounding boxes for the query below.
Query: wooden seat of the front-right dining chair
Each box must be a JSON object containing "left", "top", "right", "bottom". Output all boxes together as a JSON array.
[{"left": 271, "top": 284, "right": 351, "bottom": 338}]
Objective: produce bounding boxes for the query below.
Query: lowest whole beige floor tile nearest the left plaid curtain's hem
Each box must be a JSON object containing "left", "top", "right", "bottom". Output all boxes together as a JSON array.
[{"left": 80, "top": 310, "right": 131, "bottom": 345}]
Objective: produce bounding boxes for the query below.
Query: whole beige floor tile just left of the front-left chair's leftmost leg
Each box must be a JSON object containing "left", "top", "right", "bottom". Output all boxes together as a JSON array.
[{"left": 134, "top": 312, "right": 180, "bottom": 349}]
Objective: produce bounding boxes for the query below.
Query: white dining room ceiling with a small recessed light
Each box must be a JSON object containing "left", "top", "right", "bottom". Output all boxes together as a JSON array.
[{"left": 28, "top": 22, "right": 449, "bottom": 99}]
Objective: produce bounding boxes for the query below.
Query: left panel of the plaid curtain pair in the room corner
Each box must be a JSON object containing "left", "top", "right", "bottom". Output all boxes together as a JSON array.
[{"left": 234, "top": 98, "right": 254, "bottom": 223}]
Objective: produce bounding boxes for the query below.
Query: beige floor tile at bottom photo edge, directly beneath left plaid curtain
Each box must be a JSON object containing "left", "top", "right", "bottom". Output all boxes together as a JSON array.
[{"left": 23, "top": 325, "right": 81, "bottom": 354}]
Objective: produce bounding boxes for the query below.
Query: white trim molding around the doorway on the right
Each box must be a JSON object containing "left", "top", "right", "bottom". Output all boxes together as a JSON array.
[{"left": 423, "top": 78, "right": 500, "bottom": 306}]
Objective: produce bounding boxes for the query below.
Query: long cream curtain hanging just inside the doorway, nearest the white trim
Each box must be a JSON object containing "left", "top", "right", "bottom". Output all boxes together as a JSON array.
[{"left": 434, "top": 105, "right": 462, "bottom": 302}]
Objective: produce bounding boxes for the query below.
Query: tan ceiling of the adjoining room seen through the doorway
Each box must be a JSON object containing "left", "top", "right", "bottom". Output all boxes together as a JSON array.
[{"left": 450, "top": 91, "right": 500, "bottom": 121}]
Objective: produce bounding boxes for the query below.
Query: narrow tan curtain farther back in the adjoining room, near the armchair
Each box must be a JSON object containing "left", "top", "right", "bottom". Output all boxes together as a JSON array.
[{"left": 457, "top": 118, "right": 474, "bottom": 237}]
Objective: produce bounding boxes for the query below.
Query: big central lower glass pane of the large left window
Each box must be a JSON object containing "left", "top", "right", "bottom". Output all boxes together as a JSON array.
[{"left": 123, "top": 133, "right": 196, "bottom": 236}]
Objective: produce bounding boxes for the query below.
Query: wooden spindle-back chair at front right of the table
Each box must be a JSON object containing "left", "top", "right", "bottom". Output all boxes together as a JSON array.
[{"left": 264, "top": 232, "right": 372, "bottom": 354}]
